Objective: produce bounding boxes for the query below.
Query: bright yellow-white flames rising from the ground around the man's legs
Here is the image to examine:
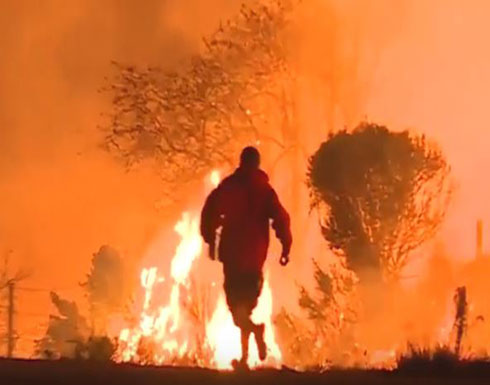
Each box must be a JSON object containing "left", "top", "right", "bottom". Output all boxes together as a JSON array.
[{"left": 115, "top": 171, "right": 282, "bottom": 369}]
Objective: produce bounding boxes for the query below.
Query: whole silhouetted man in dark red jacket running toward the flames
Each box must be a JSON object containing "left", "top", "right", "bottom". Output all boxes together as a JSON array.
[{"left": 201, "top": 147, "right": 292, "bottom": 366}]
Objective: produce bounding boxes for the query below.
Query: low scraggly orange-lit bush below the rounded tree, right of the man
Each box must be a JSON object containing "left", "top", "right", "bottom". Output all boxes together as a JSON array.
[{"left": 276, "top": 262, "right": 357, "bottom": 369}]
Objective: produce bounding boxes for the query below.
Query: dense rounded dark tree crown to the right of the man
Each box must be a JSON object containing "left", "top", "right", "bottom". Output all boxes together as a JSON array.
[{"left": 308, "top": 123, "right": 451, "bottom": 281}]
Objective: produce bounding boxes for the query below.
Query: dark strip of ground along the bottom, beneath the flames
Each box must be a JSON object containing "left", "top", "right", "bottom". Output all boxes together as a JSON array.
[{"left": 0, "top": 360, "right": 490, "bottom": 385}]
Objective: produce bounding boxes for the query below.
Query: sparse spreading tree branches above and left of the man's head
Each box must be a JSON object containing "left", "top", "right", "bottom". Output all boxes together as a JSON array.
[{"left": 105, "top": 0, "right": 298, "bottom": 200}]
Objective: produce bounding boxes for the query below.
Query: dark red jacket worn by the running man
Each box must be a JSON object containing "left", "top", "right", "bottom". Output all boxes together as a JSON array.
[{"left": 201, "top": 168, "right": 292, "bottom": 271}]
